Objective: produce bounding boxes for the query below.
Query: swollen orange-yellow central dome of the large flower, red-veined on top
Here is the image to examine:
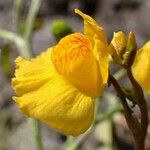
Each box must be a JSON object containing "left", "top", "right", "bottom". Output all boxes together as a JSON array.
[{"left": 52, "top": 33, "right": 103, "bottom": 97}]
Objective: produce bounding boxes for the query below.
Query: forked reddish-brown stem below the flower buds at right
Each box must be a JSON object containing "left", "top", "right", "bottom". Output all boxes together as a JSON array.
[{"left": 109, "top": 74, "right": 148, "bottom": 150}]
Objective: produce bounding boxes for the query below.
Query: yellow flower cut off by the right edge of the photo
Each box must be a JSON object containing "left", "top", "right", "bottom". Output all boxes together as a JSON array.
[{"left": 132, "top": 41, "right": 150, "bottom": 92}]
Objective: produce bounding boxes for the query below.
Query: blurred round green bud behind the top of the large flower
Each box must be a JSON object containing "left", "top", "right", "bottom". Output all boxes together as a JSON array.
[{"left": 52, "top": 19, "right": 72, "bottom": 41}]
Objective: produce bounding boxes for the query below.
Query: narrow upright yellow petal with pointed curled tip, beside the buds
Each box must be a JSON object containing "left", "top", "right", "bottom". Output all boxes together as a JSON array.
[{"left": 75, "top": 9, "right": 108, "bottom": 84}]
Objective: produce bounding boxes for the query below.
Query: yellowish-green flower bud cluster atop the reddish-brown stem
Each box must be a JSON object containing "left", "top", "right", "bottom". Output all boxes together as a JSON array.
[{"left": 109, "top": 31, "right": 137, "bottom": 68}]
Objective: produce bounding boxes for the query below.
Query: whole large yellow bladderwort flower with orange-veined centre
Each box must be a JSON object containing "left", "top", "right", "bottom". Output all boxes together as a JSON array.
[{"left": 12, "top": 10, "right": 108, "bottom": 136}]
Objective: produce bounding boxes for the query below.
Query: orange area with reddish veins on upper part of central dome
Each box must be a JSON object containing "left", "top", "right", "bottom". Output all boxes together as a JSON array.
[{"left": 52, "top": 33, "right": 91, "bottom": 74}]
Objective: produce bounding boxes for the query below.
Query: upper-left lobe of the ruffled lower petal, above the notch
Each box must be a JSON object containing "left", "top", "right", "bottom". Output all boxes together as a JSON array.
[{"left": 12, "top": 49, "right": 55, "bottom": 95}]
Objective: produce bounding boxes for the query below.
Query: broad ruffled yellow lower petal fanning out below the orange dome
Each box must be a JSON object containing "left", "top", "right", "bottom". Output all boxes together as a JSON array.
[{"left": 12, "top": 50, "right": 94, "bottom": 136}]
